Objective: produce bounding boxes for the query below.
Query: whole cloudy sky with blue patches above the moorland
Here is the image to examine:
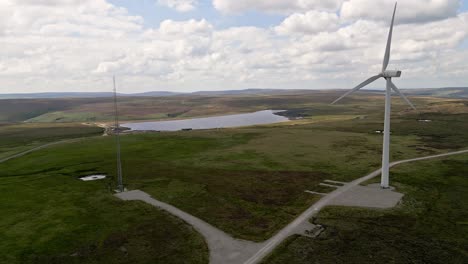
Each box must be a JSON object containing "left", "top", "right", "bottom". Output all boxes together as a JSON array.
[{"left": 0, "top": 0, "right": 468, "bottom": 93}]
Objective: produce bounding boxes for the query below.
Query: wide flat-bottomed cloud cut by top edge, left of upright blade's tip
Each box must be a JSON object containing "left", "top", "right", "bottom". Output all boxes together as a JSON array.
[{"left": 213, "top": 0, "right": 342, "bottom": 14}]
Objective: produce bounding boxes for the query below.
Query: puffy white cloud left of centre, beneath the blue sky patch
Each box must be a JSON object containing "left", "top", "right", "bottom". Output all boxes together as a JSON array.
[{"left": 94, "top": 19, "right": 213, "bottom": 78}]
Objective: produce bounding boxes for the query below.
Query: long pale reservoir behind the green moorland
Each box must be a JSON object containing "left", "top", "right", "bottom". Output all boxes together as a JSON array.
[{"left": 122, "top": 110, "right": 289, "bottom": 131}]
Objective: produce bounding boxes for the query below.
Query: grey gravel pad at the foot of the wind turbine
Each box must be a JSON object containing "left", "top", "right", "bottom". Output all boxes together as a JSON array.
[{"left": 330, "top": 184, "right": 403, "bottom": 208}]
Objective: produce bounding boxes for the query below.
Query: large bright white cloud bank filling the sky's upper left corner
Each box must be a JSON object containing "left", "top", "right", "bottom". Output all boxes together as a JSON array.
[{"left": 0, "top": 0, "right": 143, "bottom": 92}]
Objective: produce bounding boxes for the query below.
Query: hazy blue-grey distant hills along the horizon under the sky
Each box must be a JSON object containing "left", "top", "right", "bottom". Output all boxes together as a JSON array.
[{"left": 0, "top": 87, "right": 468, "bottom": 99}]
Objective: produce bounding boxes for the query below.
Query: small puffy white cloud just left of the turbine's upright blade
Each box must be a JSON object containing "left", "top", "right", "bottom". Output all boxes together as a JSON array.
[{"left": 276, "top": 10, "right": 339, "bottom": 34}]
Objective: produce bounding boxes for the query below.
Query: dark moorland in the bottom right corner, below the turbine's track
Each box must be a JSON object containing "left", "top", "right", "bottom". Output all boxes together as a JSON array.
[{"left": 264, "top": 155, "right": 468, "bottom": 264}]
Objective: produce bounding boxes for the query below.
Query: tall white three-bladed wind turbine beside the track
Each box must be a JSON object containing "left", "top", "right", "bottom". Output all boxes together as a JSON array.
[{"left": 332, "top": 3, "right": 416, "bottom": 189}]
